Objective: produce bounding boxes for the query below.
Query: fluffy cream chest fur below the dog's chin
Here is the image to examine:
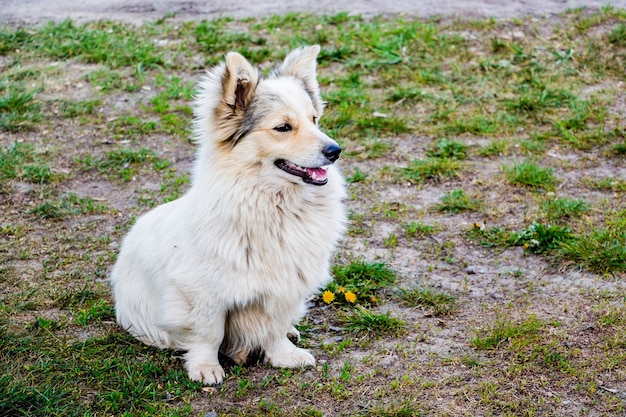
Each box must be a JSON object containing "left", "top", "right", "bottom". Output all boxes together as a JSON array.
[{"left": 183, "top": 174, "right": 344, "bottom": 300}]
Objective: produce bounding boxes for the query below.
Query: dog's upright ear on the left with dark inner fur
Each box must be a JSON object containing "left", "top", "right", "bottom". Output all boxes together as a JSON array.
[{"left": 222, "top": 52, "right": 259, "bottom": 112}]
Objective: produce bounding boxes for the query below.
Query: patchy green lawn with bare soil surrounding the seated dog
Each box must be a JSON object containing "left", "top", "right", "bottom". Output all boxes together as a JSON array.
[{"left": 0, "top": 8, "right": 626, "bottom": 416}]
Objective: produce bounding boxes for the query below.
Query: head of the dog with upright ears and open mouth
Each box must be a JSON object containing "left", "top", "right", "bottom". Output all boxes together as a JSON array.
[{"left": 194, "top": 46, "right": 341, "bottom": 185}]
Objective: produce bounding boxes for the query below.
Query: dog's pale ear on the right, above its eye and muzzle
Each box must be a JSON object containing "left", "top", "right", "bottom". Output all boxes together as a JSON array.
[{"left": 274, "top": 45, "right": 324, "bottom": 117}]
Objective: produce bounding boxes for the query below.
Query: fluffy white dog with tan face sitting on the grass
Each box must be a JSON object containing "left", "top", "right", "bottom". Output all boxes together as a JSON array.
[{"left": 111, "top": 46, "right": 345, "bottom": 384}]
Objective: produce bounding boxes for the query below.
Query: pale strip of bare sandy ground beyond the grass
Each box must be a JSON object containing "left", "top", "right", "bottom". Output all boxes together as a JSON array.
[{"left": 0, "top": 0, "right": 626, "bottom": 25}]
